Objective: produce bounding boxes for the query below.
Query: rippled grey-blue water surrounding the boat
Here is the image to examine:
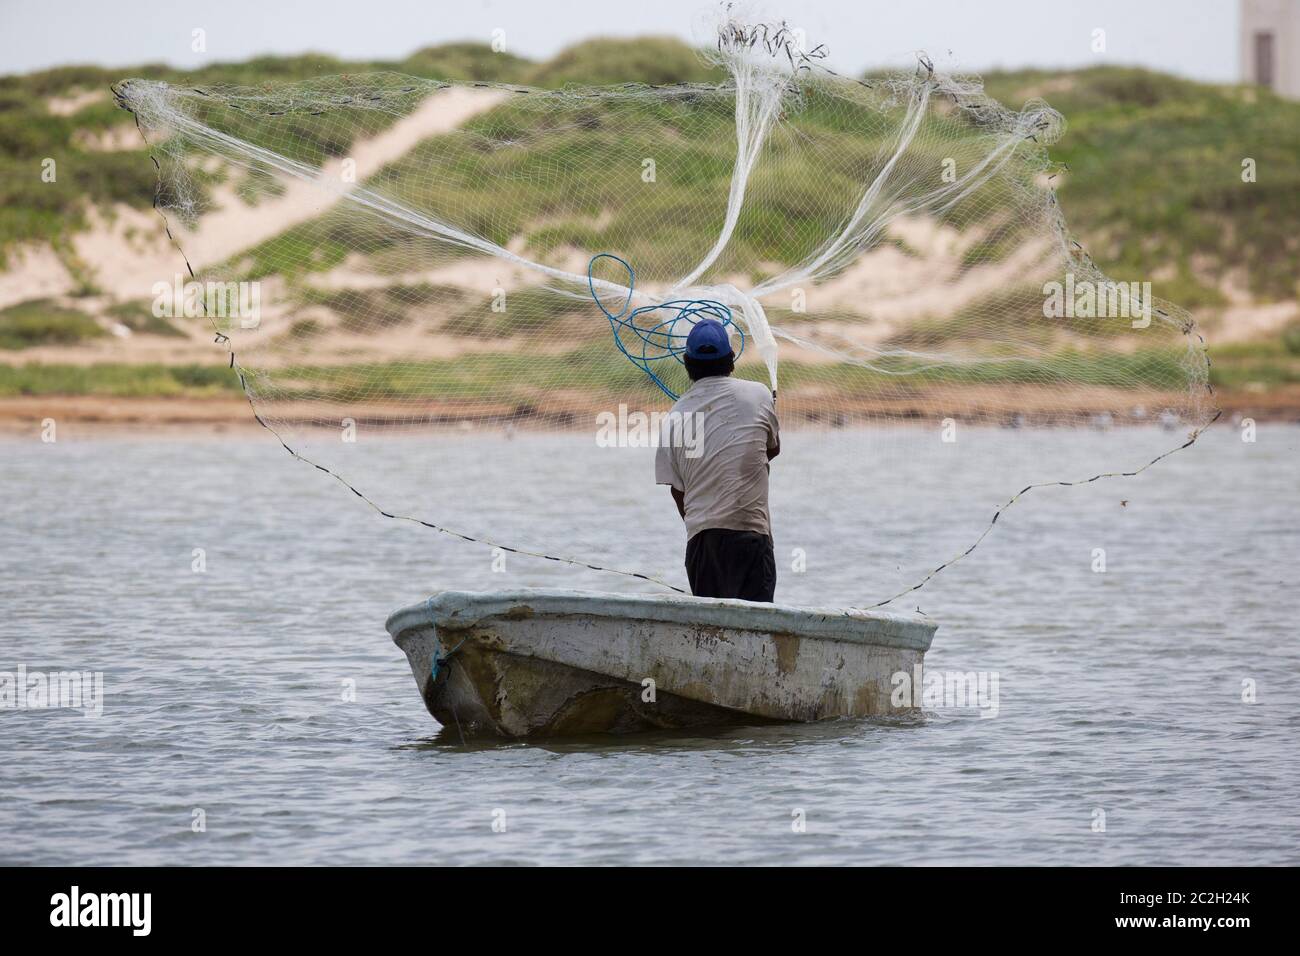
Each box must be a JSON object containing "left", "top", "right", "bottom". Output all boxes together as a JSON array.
[{"left": 0, "top": 424, "right": 1300, "bottom": 865}]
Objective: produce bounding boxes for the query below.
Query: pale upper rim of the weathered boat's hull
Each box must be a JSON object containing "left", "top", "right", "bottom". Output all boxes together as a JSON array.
[{"left": 385, "top": 588, "right": 939, "bottom": 652}]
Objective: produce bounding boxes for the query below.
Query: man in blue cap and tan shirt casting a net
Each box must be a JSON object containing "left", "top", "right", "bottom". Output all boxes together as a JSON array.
[{"left": 655, "top": 319, "right": 781, "bottom": 602}]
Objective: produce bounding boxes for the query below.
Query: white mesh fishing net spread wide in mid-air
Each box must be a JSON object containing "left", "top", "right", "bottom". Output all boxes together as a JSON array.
[{"left": 117, "top": 16, "right": 1213, "bottom": 601}]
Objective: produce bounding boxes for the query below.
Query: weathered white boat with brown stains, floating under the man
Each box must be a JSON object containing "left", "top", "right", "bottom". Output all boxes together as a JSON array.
[{"left": 387, "top": 588, "right": 937, "bottom": 737}]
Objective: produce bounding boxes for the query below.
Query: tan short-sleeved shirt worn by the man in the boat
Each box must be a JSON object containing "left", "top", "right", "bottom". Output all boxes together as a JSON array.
[{"left": 654, "top": 376, "right": 780, "bottom": 540}]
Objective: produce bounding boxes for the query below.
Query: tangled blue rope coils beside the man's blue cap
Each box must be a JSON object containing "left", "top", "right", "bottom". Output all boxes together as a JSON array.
[{"left": 586, "top": 252, "right": 745, "bottom": 402}]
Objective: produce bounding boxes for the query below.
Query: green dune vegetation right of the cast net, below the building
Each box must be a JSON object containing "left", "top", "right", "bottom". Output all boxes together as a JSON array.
[{"left": 985, "top": 66, "right": 1300, "bottom": 307}]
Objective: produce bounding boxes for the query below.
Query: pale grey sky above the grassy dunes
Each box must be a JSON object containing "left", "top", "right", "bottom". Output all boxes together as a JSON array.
[{"left": 0, "top": 0, "right": 1239, "bottom": 82}]
